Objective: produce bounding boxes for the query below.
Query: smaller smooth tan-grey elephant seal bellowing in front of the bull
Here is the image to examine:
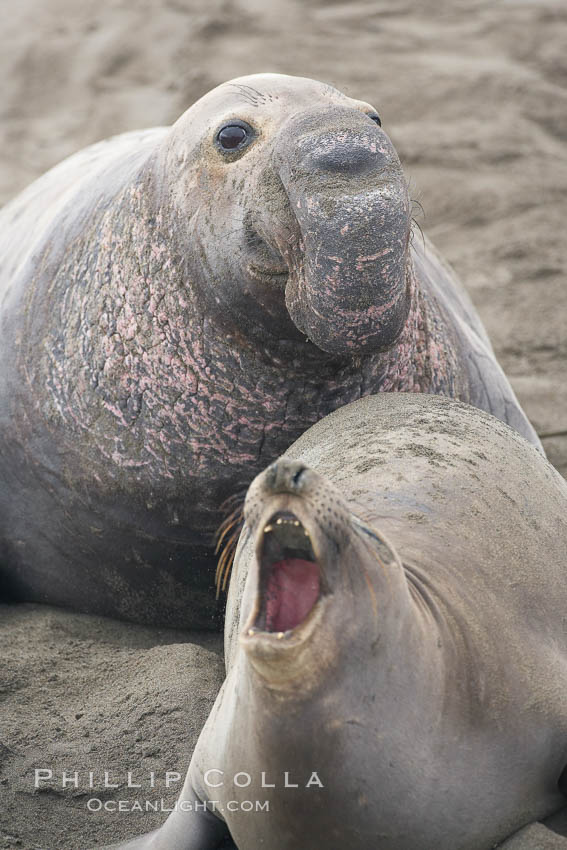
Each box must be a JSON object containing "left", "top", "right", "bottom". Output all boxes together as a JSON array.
[{"left": 106, "top": 394, "right": 567, "bottom": 850}]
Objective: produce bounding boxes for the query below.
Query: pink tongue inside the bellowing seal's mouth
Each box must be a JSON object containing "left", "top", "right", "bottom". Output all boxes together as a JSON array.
[{"left": 266, "top": 558, "right": 319, "bottom": 632}]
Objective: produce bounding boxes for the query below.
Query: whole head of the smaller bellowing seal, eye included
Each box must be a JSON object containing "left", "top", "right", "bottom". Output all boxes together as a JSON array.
[{"left": 240, "top": 458, "right": 407, "bottom": 688}]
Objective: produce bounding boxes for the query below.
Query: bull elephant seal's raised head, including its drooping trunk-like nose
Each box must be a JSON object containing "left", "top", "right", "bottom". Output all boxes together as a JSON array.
[{"left": 165, "top": 74, "right": 411, "bottom": 355}]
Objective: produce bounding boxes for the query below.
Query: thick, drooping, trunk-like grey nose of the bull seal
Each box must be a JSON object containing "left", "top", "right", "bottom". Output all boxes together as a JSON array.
[{"left": 273, "top": 107, "right": 411, "bottom": 357}]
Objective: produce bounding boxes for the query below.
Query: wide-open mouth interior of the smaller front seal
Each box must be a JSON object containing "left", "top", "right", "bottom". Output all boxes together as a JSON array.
[{"left": 253, "top": 511, "right": 324, "bottom": 637}]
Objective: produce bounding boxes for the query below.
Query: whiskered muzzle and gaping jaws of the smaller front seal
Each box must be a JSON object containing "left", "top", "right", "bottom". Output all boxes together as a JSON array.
[{"left": 239, "top": 457, "right": 350, "bottom": 680}]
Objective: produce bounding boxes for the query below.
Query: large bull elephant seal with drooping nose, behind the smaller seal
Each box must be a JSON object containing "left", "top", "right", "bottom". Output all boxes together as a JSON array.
[{"left": 0, "top": 74, "right": 537, "bottom": 628}]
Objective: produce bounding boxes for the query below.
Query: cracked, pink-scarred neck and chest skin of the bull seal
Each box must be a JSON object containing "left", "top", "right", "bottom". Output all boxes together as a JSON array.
[{"left": 14, "top": 170, "right": 468, "bottom": 531}]
